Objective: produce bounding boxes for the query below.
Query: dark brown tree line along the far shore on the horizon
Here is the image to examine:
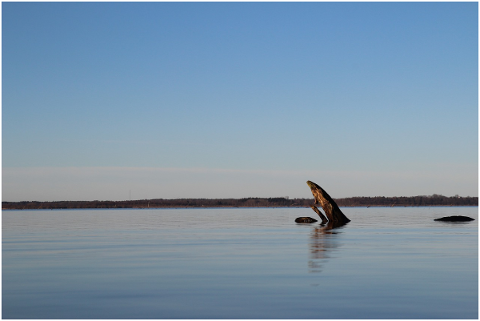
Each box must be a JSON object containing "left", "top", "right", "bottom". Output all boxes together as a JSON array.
[{"left": 2, "top": 194, "right": 478, "bottom": 210}]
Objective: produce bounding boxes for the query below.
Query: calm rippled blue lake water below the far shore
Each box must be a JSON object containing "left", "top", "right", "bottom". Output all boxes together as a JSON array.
[{"left": 2, "top": 207, "right": 478, "bottom": 319}]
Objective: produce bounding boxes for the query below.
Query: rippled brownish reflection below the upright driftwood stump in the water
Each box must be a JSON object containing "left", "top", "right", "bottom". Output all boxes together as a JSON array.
[{"left": 308, "top": 222, "right": 345, "bottom": 273}]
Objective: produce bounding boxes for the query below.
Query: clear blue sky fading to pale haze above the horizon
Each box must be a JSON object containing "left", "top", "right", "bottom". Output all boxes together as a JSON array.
[{"left": 2, "top": 2, "right": 478, "bottom": 201}]
